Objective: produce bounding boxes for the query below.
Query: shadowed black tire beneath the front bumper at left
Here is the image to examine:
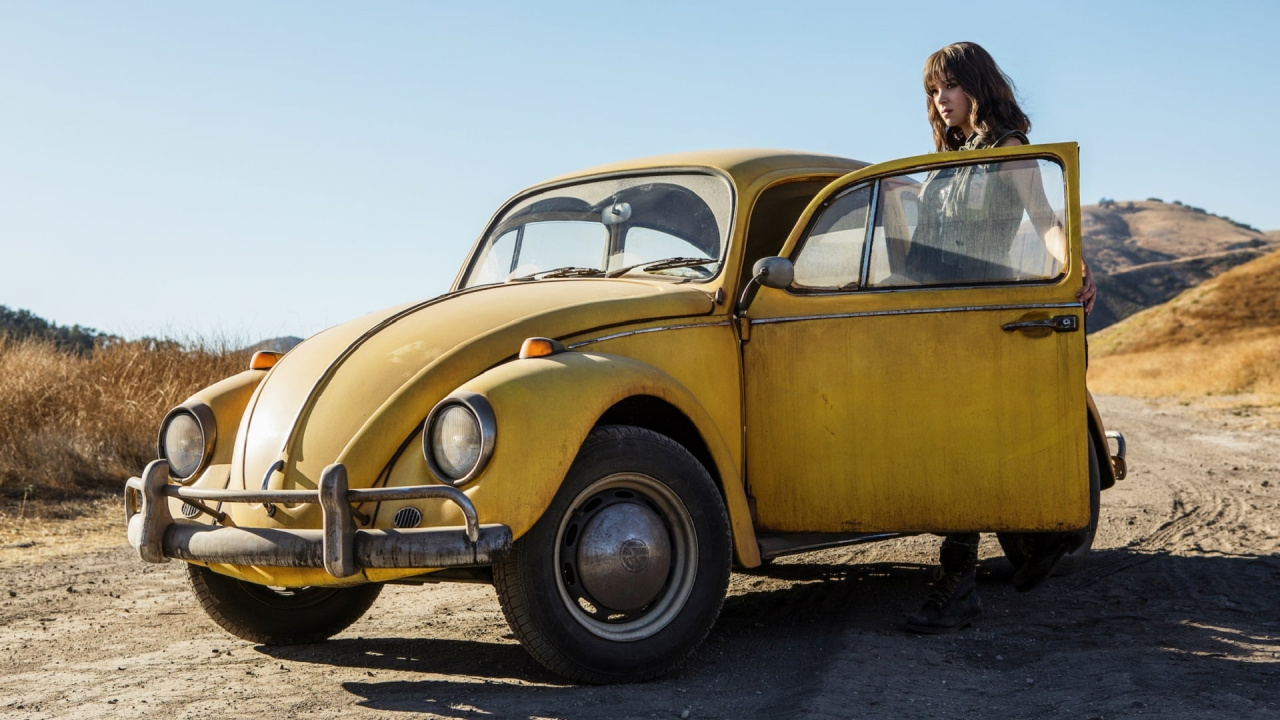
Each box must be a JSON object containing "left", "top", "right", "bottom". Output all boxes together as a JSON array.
[{"left": 187, "top": 564, "right": 383, "bottom": 644}]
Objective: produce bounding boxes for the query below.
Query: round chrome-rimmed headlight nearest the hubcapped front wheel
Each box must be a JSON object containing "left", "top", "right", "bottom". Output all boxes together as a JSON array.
[{"left": 422, "top": 392, "right": 495, "bottom": 486}]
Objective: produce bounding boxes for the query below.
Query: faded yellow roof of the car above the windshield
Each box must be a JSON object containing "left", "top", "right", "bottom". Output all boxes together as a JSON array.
[{"left": 540, "top": 149, "right": 869, "bottom": 187}]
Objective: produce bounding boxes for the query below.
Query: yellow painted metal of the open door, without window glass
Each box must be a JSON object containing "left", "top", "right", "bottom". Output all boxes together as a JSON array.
[{"left": 744, "top": 143, "right": 1089, "bottom": 532}]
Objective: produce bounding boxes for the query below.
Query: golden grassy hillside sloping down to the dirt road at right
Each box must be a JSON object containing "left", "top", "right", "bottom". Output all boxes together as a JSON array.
[{"left": 1089, "top": 245, "right": 1280, "bottom": 400}]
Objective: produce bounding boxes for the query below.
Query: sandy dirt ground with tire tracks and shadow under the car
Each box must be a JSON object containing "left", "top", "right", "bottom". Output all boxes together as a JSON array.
[{"left": 0, "top": 397, "right": 1280, "bottom": 719}]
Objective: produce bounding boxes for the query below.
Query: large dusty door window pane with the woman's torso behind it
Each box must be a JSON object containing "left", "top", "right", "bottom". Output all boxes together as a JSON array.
[{"left": 865, "top": 159, "right": 1066, "bottom": 287}]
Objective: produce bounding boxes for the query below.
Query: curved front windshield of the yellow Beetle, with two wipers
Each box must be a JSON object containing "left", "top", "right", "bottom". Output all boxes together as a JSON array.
[{"left": 462, "top": 173, "right": 732, "bottom": 287}]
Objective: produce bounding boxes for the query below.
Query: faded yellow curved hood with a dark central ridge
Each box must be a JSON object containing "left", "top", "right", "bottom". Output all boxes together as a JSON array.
[{"left": 230, "top": 278, "right": 714, "bottom": 502}]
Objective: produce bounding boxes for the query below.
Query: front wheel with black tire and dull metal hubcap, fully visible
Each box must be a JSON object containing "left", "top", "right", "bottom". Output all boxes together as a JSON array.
[{"left": 494, "top": 425, "right": 731, "bottom": 684}]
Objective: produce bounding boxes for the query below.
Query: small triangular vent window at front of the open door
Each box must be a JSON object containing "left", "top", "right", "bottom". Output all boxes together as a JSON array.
[{"left": 792, "top": 184, "right": 872, "bottom": 290}]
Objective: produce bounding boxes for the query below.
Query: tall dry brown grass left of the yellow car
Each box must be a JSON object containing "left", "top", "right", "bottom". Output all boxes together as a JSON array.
[{"left": 0, "top": 338, "right": 247, "bottom": 499}]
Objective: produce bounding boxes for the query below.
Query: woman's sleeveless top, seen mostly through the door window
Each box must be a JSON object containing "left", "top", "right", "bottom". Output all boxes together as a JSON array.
[{"left": 908, "top": 131, "right": 1030, "bottom": 282}]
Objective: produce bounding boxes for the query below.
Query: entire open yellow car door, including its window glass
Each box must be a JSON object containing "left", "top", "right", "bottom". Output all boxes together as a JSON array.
[{"left": 742, "top": 143, "right": 1089, "bottom": 532}]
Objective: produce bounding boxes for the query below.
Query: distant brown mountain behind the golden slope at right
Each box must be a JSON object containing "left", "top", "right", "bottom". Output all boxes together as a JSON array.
[{"left": 1080, "top": 199, "right": 1280, "bottom": 332}]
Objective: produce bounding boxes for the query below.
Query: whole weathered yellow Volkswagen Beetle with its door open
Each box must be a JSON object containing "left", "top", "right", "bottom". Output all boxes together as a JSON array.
[{"left": 125, "top": 143, "right": 1124, "bottom": 683}]
